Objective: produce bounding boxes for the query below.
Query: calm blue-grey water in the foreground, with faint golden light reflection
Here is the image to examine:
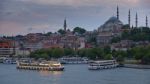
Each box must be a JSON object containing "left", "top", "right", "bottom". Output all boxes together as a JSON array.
[{"left": 0, "top": 64, "right": 150, "bottom": 84}]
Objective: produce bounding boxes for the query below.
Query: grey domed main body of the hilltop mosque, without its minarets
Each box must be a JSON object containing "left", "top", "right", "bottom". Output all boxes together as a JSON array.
[{"left": 97, "top": 17, "right": 123, "bottom": 45}]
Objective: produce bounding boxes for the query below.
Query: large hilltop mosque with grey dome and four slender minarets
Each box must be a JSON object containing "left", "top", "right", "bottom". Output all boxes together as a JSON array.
[{"left": 96, "top": 6, "right": 148, "bottom": 46}]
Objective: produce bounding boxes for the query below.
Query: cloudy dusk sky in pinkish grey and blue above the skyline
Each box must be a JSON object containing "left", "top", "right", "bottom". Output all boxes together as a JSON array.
[{"left": 0, "top": 0, "right": 150, "bottom": 36}]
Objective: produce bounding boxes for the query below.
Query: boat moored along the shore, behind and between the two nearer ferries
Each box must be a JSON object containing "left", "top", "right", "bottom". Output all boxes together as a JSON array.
[{"left": 59, "top": 57, "right": 88, "bottom": 64}]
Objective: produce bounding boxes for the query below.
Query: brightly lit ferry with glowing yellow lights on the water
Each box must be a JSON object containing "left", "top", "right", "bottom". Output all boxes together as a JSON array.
[{"left": 17, "top": 61, "right": 64, "bottom": 71}]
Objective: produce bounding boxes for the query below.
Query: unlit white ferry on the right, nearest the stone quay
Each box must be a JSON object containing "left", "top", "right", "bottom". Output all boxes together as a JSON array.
[{"left": 88, "top": 60, "right": 118, "bottom": 70}]
